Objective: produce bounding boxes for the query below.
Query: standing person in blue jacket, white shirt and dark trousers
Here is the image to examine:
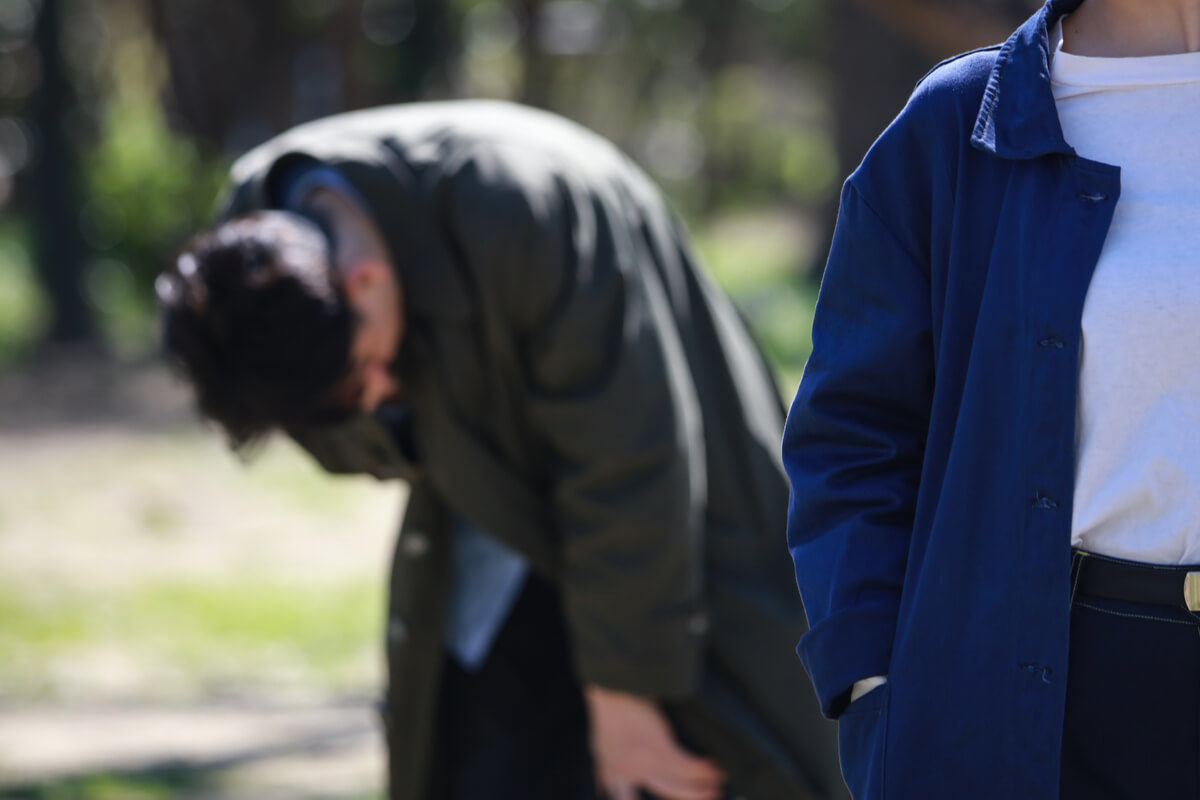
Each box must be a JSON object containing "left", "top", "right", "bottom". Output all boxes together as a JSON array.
[{"left": 784, "top": 0, "right": 1200, "bottom": 800}]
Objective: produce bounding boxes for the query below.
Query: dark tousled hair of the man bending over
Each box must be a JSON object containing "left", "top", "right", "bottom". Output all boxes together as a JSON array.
[{"left": 155, "top": 211, "right": 355, "bottom": 450}]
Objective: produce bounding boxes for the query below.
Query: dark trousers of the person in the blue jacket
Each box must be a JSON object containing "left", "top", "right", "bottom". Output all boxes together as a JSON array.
[{"left": 1060, "top": 585, "right": 1200, "bottom": 800}]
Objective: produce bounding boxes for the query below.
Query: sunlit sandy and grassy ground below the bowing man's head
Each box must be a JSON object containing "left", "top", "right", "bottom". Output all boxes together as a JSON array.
[{"left": 0, "top": 432, "right": 403, "bottom": 700}]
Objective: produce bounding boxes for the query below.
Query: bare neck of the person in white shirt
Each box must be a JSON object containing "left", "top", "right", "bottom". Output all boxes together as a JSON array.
[{"left": 1062, "top": 0, "right": 1200, "bottom": 58}]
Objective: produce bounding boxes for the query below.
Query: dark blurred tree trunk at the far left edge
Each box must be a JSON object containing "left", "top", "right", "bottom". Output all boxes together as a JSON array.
[{"left": 30, "top": 0, "right": 98, "bottom": 344}]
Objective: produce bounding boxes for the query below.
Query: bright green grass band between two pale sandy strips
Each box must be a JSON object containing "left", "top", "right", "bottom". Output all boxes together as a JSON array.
[{"left": 0, "top": 573, "right": 384, "bottom": 698}]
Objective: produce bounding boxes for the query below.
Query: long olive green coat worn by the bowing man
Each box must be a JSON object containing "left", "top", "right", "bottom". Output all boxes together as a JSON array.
[{"left": 226, "top": 102, "right": 845, "bottom": 800}]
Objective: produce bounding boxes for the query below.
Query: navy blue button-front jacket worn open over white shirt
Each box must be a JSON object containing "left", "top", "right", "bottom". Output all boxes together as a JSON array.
[{"left": 784, "top": 0, "right": 1120, "bottom": 800}]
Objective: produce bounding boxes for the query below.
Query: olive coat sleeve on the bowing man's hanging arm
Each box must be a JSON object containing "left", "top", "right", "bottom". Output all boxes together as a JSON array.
[{"left": 452, "top": 149, "right": 707, "bottom": 697}]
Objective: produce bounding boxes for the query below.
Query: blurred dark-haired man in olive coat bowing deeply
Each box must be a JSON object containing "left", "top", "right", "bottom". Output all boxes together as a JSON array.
[{"left": 157, "top": 102, "right": 845, "bottom": 800}]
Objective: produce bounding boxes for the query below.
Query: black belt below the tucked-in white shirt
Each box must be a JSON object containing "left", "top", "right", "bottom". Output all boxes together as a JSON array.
[{"left": 1072, "top": 551, "right": 1200, "bottom": 612}]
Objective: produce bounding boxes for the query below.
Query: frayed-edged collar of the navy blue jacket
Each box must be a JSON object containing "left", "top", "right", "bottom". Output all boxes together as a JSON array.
[{"left": 971, "top": 0, "right": 1084, "bottom": 158}]
